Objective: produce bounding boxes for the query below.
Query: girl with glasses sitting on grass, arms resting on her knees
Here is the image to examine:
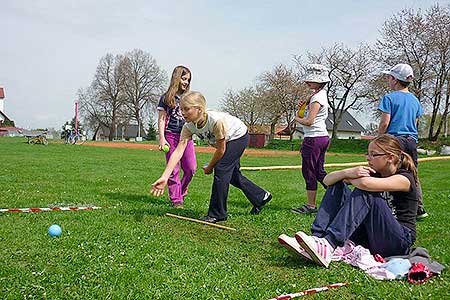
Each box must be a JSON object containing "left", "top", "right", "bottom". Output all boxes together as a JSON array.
[{"left": 278, "top": 134, "right": 418, "bottom": 267}]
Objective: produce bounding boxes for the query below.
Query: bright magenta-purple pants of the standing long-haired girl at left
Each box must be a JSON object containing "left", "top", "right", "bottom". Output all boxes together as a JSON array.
[{"left": 164, "top": 131, "right": 197, "bottom": 203}]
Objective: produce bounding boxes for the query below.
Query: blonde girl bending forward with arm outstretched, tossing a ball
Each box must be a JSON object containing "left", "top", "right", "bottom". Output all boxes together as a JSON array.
[{"left": 151, "top": 92, "right": 272, "bottom": 223}]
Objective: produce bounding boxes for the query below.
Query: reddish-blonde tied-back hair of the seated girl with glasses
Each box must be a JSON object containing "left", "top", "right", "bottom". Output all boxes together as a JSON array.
[{"left": 372, "top": 134, "right": 418, "bottom": 184}]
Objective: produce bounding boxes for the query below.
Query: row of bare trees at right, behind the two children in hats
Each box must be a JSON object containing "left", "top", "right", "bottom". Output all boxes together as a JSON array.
[{"left": 221, "top": 5, "right": 450, "bottom": 140}]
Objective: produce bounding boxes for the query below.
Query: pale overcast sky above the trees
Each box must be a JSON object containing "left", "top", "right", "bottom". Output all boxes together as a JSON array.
[{"left": 0, "top": 0, "right": 449, "bottom": 129}]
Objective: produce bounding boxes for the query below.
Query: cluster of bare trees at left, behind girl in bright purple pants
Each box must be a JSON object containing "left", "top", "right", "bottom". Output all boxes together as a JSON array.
[{"left": 78, "top": 49, "right": 166, "bottom": 140}]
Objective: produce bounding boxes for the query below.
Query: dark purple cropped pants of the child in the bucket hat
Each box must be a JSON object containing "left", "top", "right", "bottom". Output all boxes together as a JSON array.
[{"left": 301, "top": 136, "right": 330, "bottom": 191}]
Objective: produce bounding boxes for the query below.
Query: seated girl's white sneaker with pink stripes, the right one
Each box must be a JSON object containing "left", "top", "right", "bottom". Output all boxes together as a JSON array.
[{"left": 295, "top": 231, "right": 334, "bottom": 268}]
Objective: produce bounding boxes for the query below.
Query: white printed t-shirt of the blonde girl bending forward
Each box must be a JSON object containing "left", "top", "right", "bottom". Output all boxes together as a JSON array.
[{"left": 181, "top": 110, "right": 247, "bottom": 147}]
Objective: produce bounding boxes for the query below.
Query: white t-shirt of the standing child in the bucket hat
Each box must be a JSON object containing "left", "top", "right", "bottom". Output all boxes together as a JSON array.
[{"left": 302, "top": 89, "right": 328, "bottom": 137}]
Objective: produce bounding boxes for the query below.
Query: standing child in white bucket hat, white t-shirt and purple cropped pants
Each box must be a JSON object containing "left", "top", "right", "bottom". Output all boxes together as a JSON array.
[{"left": 292, "top": 64, "right": 330, "bottom": 214}]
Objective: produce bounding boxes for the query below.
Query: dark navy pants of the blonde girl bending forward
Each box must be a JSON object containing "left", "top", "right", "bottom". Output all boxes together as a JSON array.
[{"left": 208, "top": 133, "right": 266, "bottom": 219}]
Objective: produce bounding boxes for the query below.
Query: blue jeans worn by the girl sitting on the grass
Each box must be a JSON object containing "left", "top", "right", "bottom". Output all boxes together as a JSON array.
[{"left": 311, "top": 181, "right": 412, "bottom": 257}]
